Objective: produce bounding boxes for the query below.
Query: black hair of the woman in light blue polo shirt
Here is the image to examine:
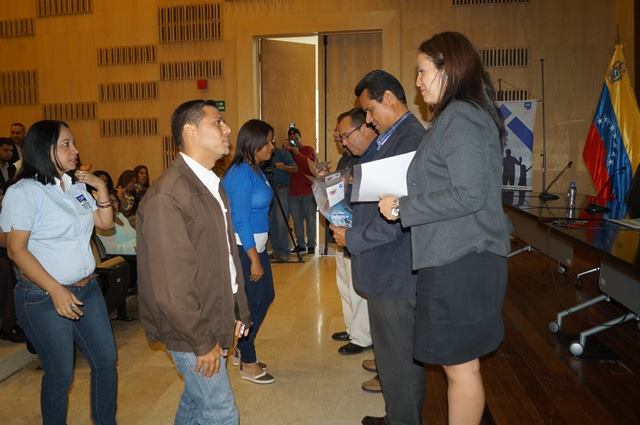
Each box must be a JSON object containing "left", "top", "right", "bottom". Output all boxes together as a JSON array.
[{"left": 16, "top": 120, "right": 69, "bottom": 184}]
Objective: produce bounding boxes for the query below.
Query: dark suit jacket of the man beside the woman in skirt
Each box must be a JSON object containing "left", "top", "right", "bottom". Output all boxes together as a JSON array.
[{"left": 346, "top": 114, "right": 426, "bottom": 299}]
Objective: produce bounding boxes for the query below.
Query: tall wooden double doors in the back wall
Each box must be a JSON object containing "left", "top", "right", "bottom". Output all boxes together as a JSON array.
[{"left": 257, "top": 31, "right": 383, "bottom": 254}]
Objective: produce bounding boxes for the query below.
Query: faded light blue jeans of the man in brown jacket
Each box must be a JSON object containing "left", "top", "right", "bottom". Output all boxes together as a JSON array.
[{"left": 169, "top": 351, "right": 238, "bottom": 425}]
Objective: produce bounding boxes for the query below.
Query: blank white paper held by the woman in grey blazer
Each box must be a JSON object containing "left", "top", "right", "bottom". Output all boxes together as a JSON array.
[{"left": 351, "top": 152, "right": 415, "bottom": 202}]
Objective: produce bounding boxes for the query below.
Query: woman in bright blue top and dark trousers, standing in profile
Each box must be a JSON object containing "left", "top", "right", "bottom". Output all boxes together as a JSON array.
[{"left": 222, "top": 119, "right": 275, "bottom": 384}]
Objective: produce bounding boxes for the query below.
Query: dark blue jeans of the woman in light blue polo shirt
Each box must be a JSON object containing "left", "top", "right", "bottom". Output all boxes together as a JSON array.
[{"left": 14, "top": 278, "right": 117, "bottom": 425}]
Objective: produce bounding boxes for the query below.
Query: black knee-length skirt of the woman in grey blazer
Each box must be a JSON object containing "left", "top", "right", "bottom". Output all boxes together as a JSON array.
[{"left": 414, "top": 252, "right": 507, "bottom": 365}]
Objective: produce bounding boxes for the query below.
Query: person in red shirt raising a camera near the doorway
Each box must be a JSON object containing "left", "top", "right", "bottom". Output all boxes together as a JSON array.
[{"left": 285, "top": 123, "right": 316, "bottom": 254}]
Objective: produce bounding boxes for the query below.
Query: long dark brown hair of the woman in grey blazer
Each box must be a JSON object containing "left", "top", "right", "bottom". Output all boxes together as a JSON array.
[{"left": 418, "top": 32, "right": 507, "bottom": 145}]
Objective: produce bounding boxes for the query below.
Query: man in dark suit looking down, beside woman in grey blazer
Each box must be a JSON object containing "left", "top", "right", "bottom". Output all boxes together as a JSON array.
[{"left": 333, "top": 70, "right": 425, "bottom": 425}]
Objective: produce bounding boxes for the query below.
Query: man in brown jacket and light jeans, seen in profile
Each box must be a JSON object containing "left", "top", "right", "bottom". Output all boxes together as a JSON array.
[{"left": 136, "top": 100, "right": 250, "bottom": 425}]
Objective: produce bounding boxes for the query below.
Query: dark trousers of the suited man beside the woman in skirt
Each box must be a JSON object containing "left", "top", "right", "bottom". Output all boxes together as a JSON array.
[{"left": 367, "top": 296, "right": 425, "bottom": 425}]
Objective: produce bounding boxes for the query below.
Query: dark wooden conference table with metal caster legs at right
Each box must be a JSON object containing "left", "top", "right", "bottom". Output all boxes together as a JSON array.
[{"left": 502, "top": 191, "right": 640, "bottom": 356}]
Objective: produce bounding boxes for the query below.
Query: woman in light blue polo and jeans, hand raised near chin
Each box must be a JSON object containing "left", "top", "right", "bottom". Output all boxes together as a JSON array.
[{"left": 0, "top": 120, "right": 116, "bottom": 425}]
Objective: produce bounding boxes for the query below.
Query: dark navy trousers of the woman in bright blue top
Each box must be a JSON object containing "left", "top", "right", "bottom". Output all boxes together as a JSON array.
[{"left": 238, "top": 245, "right": 275, "bottom": 363}]
